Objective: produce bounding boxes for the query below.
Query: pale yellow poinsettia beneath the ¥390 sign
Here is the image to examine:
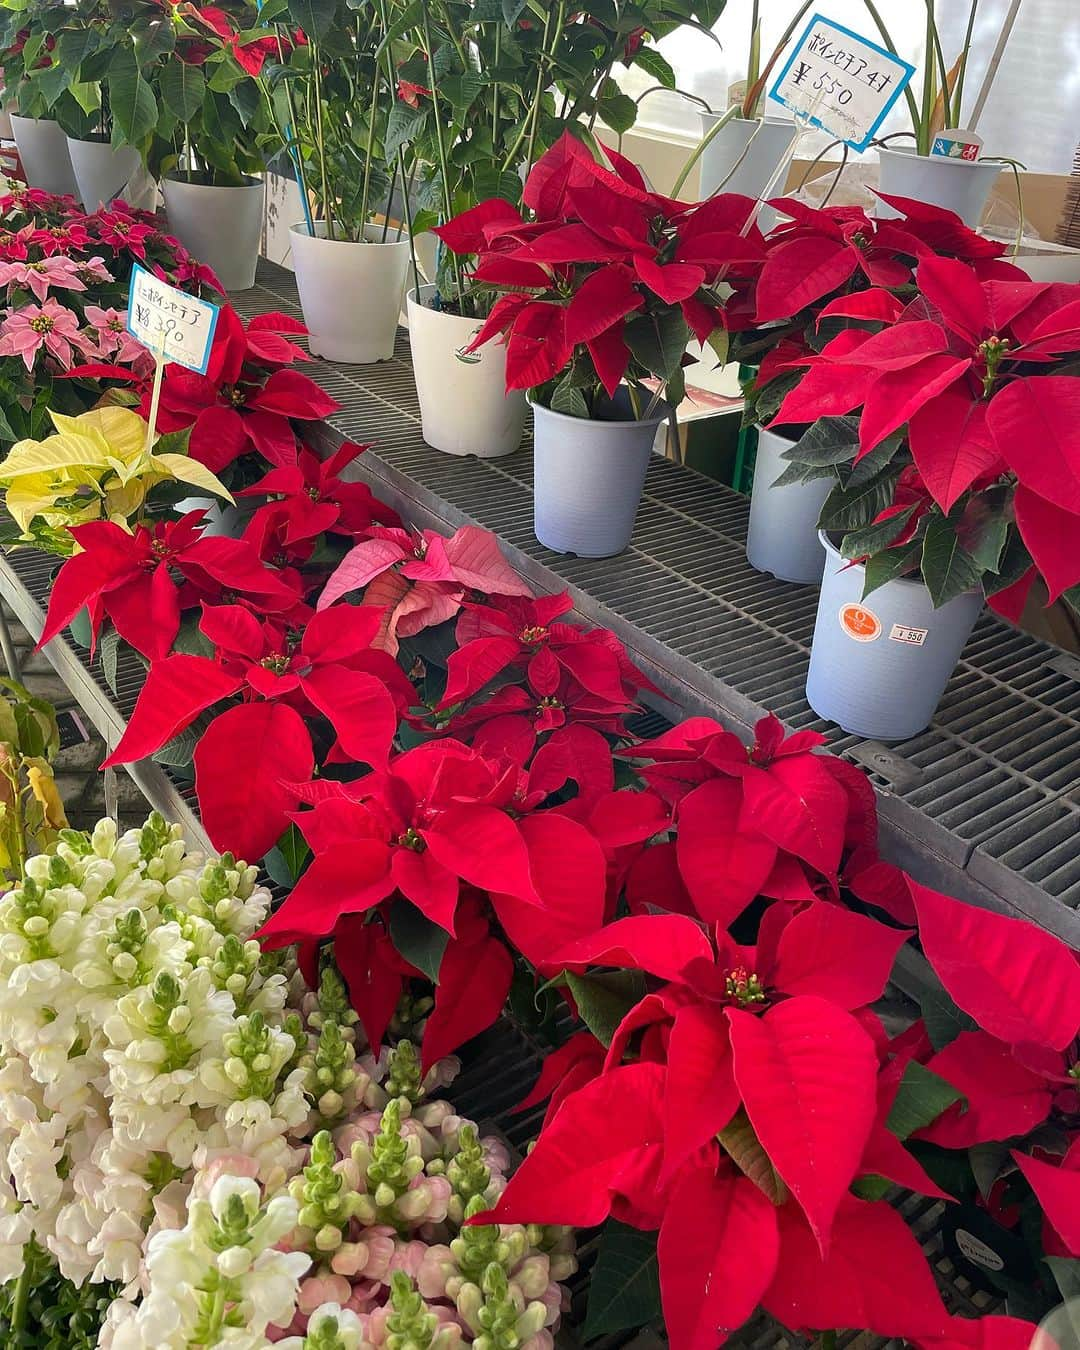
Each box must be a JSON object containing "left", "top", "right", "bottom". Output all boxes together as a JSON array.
[{"left": 0, "top": 405, "right": 232, "bottom": 554}]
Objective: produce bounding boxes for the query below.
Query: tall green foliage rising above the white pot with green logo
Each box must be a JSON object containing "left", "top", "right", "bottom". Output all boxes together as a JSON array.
[{"left": 383, "top": 0, "right": 725, "bottom": 313}]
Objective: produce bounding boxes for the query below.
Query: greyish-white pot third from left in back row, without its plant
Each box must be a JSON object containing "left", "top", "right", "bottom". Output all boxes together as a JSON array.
[{"left": 161, "top": 178, "right": 266, "bottom": 292}]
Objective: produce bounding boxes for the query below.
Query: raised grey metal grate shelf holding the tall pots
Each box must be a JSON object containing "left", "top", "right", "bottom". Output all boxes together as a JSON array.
[{"left": 236, "top": 262, "right": 1080, "bottom": 948}]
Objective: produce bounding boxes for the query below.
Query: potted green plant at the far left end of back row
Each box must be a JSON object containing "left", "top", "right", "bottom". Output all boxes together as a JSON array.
[{"left": 0, "top": 4, "right": 85, "bottom": 196}]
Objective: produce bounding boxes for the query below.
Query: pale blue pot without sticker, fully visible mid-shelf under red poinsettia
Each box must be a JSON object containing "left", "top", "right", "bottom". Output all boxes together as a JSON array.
[{"left": 533, "top": 404, "right": 667, "bottom": 558}]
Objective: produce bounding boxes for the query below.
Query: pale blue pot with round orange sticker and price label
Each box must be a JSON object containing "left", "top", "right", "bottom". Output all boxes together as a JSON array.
[{"left": 806, "top": 532, "right": 983, "bottom": 741}]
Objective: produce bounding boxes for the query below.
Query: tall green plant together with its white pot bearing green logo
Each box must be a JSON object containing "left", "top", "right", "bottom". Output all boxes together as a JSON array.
[{"left": 380, "top": 0, "right": 724, "bottom": 458}]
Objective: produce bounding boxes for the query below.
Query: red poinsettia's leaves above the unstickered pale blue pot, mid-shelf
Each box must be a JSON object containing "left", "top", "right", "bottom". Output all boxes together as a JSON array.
[{"left": 433, "top": 132, "right": 763, "bottom": 417}]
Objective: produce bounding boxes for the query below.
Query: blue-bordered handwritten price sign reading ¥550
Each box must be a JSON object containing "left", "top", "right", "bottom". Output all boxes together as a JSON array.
[{"left": 768, "top": 14, "right": 915, "bottom": 150}]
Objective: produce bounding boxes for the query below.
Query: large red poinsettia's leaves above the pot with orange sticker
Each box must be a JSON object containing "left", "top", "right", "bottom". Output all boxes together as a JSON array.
[{"left": 775, "top": 258, "right": 1080, "bottom": 618}]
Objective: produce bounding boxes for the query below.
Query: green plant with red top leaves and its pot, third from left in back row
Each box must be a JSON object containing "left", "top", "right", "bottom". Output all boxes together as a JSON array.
[{"left": 137, "top": 0, "right": 275, "bottom": 292}]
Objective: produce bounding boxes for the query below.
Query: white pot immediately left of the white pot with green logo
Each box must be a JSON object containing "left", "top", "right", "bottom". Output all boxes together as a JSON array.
[{"left": 289, "top": 220, "right": 409, "bottom": 366}]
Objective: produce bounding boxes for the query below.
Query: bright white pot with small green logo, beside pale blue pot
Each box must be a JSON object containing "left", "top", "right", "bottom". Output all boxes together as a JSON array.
[{"left": 409, "top": 286, "right": 528, "bottom": 459}]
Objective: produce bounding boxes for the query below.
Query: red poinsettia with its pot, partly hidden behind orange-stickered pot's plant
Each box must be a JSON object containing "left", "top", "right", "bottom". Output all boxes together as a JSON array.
[{"left": 725, "top": 198, "right": 1023, "bottom": 585}]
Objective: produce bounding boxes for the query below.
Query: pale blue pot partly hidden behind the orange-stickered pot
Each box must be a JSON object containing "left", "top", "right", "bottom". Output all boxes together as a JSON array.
[{"left": 747, "top": 428, "right": 836, "bottom": 586}]
